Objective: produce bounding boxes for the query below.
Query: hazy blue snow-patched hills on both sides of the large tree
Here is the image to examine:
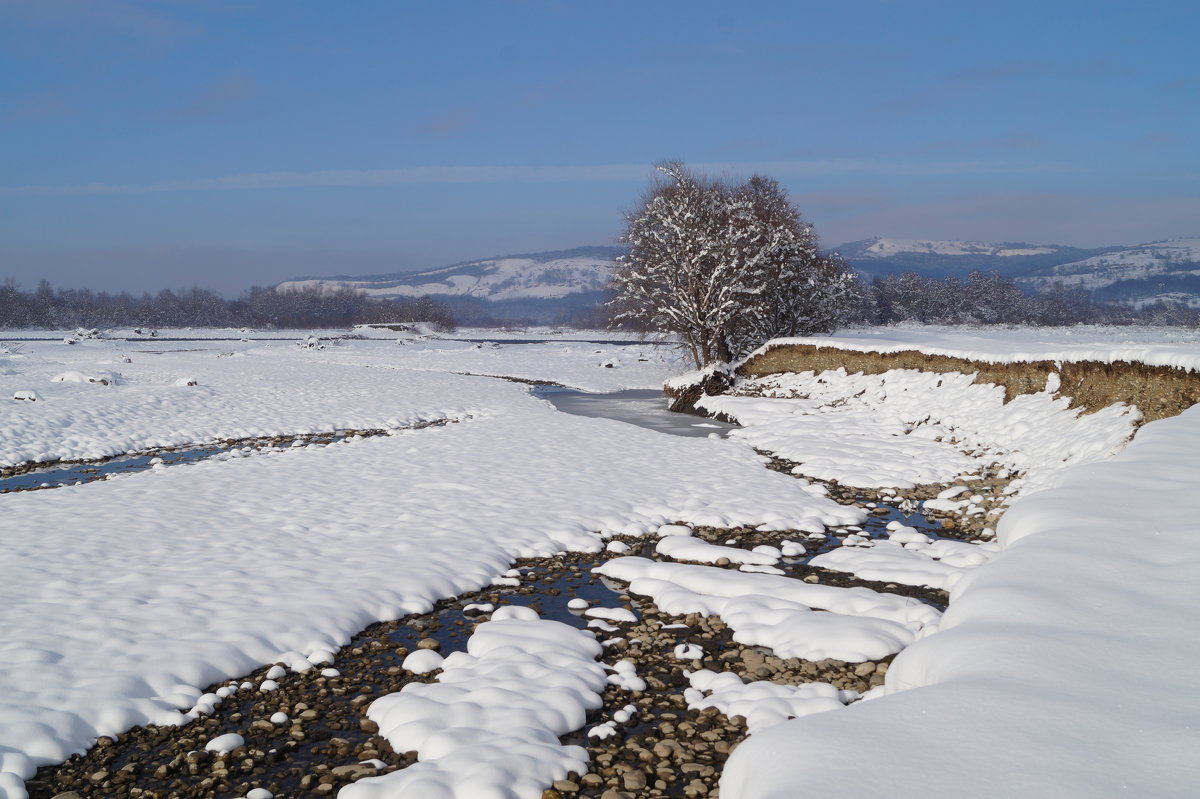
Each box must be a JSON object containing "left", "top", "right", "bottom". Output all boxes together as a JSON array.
[{"left": 278, "top": 238, "right": 1200, "bottom": 324}]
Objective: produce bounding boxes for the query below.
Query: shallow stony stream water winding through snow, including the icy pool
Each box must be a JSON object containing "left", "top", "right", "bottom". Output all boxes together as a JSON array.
[{"left": 23, "top": 385, "right": 964, "bottom": 799}]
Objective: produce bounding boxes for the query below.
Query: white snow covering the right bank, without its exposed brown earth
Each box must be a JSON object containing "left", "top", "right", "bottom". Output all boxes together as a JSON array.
[{"left": 706, "top": 328, "right": 1200, "bottom": 799}]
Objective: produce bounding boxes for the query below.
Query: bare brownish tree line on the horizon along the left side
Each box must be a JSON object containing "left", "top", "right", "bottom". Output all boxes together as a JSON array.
[{"left": 0, "top": 281, "right": 455, "bottom": 330}]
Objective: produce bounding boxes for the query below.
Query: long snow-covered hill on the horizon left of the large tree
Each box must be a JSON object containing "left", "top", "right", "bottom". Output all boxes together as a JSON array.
[{"left": 280, "top": 247, "right": 622, "bottom": 301}]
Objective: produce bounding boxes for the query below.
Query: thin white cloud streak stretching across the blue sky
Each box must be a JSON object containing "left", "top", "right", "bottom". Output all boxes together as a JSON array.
[{"left": 0, "top": 158, "right": 1063, "bottom": 194}]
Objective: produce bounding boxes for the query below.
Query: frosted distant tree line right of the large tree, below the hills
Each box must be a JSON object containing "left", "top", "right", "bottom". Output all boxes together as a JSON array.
[{"left": 846, "top": 272, "right": 1200, "bottom": 326}]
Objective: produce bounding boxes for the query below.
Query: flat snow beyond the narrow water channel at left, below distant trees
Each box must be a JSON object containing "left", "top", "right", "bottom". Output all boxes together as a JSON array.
[{"left": 0, "top": 333, "right": 674, "bottom": 468}]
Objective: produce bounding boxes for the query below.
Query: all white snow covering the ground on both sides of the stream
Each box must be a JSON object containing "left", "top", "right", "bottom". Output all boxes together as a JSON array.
[{"left": 0, "top": 329, "right": 1200, "bottom": 799}]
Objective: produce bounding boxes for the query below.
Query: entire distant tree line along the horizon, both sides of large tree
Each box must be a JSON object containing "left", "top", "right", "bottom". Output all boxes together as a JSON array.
[{"left": 0, "top": 266, "right": 1200, "bottom": 333}]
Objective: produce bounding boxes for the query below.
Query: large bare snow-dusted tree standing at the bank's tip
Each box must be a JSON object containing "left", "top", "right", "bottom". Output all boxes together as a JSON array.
[{"left": 612, "top": 161, "right": 854, "bottom": 366}]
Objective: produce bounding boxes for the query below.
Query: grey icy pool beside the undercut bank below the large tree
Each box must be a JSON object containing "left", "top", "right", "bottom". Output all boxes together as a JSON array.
[{"left": 533, "top": 385, "right": 736, "bottom": 438}]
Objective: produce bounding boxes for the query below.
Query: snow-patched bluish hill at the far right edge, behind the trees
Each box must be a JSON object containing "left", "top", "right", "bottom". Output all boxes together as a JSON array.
[{"left": 1018, "top": 239, "right": 1200, "bottom": 304}]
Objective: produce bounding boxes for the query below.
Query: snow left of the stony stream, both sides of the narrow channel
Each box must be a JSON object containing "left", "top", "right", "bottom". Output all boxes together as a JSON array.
[{"left": 0, "top": 333, "right": 862, "bottom": 799}]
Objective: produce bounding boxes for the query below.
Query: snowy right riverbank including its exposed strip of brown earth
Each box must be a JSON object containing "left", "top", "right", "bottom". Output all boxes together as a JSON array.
[{"left": 672, "top": 330, "right": 1200, "bottom": 799}]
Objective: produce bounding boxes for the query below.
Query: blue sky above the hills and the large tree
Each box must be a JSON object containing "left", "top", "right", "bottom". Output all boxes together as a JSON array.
[{"left": 0, "top": 0, "right": 1200, "bottom": 294}]
